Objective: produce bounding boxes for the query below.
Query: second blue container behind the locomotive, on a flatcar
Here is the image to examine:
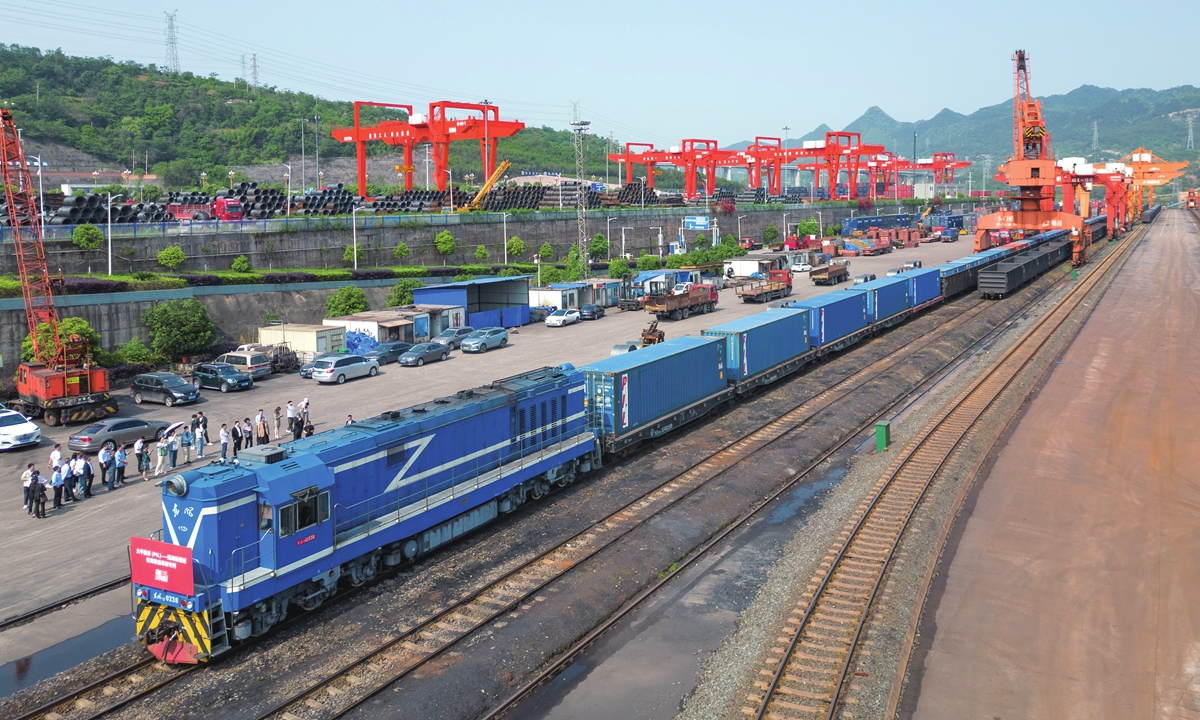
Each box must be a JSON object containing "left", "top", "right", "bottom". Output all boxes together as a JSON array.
[{"left": 701, "top": 308, "right": 810, "bottom": 380}]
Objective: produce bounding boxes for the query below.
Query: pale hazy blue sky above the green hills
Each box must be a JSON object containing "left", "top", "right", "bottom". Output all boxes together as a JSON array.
[{"left": 0, "top": 0, "right": 1200, "bottom": 146}]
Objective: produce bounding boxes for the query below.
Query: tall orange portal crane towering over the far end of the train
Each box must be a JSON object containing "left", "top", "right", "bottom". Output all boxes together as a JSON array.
[{"left": 974, "top": 50, "right": 1087, "bottom": 266}]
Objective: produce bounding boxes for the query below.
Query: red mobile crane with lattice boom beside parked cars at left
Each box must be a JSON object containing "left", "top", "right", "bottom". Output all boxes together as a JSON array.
[{"left": 0, "top": 108, "right": 116, "bottom": 426}]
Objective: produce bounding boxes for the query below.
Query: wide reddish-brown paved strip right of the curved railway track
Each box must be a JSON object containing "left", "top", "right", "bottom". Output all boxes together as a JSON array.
[{"left": 901, "top": 210, "right": 1200, "bottom": 720}]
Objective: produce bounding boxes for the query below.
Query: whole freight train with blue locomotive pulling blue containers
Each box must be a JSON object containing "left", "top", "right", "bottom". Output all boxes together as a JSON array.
[{"left": 130, "top": 211, "right": 1104, "bottom": 664}]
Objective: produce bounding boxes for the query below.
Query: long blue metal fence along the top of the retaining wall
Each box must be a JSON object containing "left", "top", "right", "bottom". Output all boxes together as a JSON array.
[{"left": 0, "top": 204, "right": 844, "bottom": 242}]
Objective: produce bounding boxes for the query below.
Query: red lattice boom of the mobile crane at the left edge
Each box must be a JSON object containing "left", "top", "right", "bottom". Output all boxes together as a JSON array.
[{"left": 0, "top": 108, "right": 65, "bottom": 366}]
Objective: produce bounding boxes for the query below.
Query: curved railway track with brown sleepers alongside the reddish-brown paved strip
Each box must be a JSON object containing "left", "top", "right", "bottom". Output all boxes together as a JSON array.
[{"left": 742, "top": 230, "right": 1141, "bottom": 720}]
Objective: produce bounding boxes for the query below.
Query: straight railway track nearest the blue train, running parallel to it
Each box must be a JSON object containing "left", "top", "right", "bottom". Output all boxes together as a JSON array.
[{"left": 248, "top": 294, "right": 1024, "bottom": 720}]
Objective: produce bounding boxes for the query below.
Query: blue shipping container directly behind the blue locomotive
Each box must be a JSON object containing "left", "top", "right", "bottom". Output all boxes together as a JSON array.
[{"left": 580, "top": 335, "right": 728, "bottom": 436}]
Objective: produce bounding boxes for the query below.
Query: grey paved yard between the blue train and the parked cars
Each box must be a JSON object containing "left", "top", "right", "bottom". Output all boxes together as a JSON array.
[{"left": 0, "top": 241, "right": 971, "bottom": 619}]
